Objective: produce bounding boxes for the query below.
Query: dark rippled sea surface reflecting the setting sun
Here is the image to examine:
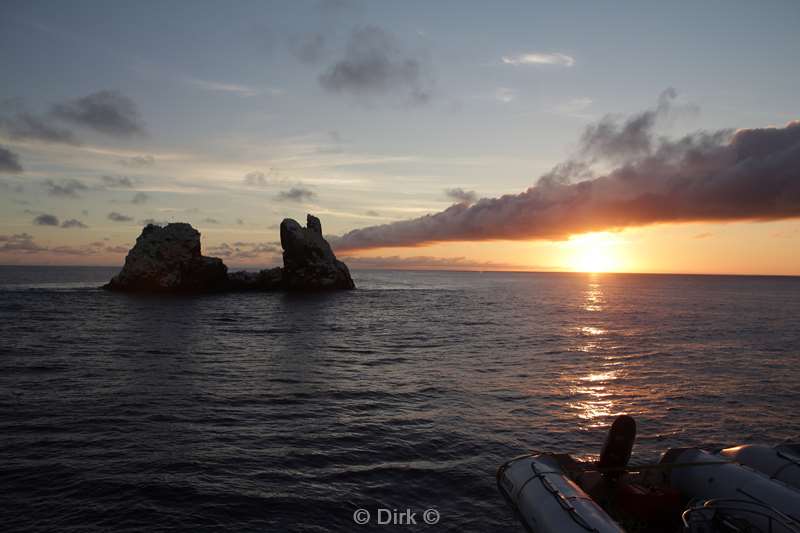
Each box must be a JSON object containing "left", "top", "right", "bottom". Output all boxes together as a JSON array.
[{"left": 0, "top": 267, "right": 800, "bottom": 532}]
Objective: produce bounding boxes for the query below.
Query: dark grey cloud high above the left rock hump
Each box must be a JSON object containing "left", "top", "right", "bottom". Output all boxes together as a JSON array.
[{"left": 51, "top": 91, "right": 144, "bottom": 137}]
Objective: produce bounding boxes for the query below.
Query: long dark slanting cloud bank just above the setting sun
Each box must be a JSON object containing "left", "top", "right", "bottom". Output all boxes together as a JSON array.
[{"left": 331, "top": 94, "right": 800, "bottom": 250}]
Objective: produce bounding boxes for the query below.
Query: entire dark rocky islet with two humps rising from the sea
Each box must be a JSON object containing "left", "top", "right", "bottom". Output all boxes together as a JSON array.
[{"left": 103, "top": 215, "right": 355, "bottom": 292}]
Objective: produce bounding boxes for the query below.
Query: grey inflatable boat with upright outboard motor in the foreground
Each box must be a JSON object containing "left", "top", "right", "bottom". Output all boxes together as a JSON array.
[{"left": 497, "top": 415, "right": 800, "bottom": 533}]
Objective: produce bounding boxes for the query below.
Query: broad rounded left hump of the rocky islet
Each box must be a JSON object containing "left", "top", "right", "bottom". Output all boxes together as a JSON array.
[{"left": 104, "top": 223, "right": 228, "bottom": 292}]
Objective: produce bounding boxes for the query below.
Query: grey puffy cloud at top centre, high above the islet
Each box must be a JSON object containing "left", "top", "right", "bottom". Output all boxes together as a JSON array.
[{"left": 319, "top": 26, "right": 431, "bottom": 103}]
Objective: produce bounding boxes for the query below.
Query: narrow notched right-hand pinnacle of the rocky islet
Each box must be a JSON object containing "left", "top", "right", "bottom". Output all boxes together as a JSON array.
[{"left": 281, "top": 215, "right": 356, "bottom": 290}]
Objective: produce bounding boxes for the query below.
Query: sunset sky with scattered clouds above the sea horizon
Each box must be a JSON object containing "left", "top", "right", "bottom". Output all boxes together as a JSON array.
[{"left": 0, "top": 0, "right": 800, "bottom": 275}]
